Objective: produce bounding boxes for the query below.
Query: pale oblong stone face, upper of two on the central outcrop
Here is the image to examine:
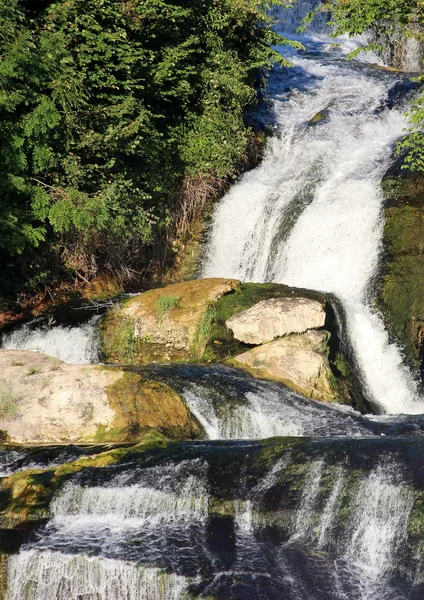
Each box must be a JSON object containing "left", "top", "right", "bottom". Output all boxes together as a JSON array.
[{"left": 226, "top": 298, "right": 326, "bottom": 345}]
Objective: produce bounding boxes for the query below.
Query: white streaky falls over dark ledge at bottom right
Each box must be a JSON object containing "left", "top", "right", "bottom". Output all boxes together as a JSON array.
[{"left": 290, "top": 461, "right": 414, "bottom": 600}]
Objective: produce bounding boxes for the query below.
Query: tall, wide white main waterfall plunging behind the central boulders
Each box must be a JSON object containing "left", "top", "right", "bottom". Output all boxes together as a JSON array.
[{"left": 202, "top": 11, "right": 424, "bottom": 413}]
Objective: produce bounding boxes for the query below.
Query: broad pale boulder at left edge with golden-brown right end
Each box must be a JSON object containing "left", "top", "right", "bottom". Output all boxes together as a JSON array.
[{"left": 0, "top": 350, "right": 201, "bottom": 443}]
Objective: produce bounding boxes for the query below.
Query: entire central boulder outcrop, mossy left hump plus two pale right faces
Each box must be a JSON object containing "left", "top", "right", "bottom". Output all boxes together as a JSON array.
[{"left": 101, "top": 279, "right": 369, "bottom": 410}]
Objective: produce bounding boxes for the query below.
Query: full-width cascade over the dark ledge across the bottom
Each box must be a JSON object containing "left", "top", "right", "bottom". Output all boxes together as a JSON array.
[{"left": 8, "top": 439, "right": 424, "bottom": 600}]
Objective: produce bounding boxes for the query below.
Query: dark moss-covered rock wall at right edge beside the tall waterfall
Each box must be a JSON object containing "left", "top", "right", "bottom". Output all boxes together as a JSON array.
[{"left": 378, "top": 163, "right": 424, "bottom": 376}]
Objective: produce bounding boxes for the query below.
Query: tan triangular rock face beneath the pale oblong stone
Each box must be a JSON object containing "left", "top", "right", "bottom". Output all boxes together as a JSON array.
[{"left": 232, "top": 330, "right": 340, "bottom": 402}]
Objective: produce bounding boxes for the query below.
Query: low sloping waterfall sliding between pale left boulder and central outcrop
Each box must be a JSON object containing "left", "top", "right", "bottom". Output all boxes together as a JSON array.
[{"left": 147, "top": 365, "right": 424, "bottom": 440}]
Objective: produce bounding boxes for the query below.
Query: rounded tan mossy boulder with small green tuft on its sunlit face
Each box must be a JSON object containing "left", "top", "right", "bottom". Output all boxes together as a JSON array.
[{"left": 102, "top": 279, "right": 240, "bottom": 364}]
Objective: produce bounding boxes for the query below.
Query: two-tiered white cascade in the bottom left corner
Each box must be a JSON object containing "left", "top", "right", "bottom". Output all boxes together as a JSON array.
[{"left": 7, "top": 460, "right": 205, "bottom": 600}]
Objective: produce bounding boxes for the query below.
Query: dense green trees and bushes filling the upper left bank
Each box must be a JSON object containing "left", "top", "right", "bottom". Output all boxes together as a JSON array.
[{"left": 0, "top": 0, "right": 291, "bottom": 299}]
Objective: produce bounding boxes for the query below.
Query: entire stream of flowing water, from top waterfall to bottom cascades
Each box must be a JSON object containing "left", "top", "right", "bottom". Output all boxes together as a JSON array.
[{"left": 0, "top": 0, "right": 424, "bottom": 600}]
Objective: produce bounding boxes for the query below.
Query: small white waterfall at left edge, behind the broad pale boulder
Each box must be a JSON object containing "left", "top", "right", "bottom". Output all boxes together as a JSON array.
[{"left": 1, "top": 315, "right": 101, "bottom": 365}]
